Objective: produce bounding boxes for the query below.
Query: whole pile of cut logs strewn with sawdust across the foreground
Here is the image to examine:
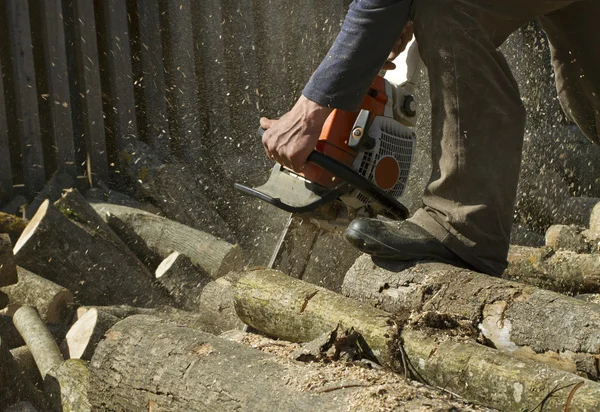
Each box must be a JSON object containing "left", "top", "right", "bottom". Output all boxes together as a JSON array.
[{"left": 0, "top": 184, "right": 600, "bottom": 411}]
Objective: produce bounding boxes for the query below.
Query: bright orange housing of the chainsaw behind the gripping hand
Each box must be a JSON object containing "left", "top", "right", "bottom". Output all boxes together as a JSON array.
[{"left": 300, "top": 76, "right": 388, "bottom": 189}]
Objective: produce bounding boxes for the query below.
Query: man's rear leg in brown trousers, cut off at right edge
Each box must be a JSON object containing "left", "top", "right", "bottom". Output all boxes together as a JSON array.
[{"left": 540, "top": 0, "right": 600, "bottom": 144}]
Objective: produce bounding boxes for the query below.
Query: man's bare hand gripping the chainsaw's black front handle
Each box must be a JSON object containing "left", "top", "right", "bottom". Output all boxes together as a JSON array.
[{"left": 260, "top": 96, "right": 333, "bottom": 172}]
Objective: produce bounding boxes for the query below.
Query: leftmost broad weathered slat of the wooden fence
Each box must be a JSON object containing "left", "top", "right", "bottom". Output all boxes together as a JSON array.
[{"left": 5, "top": 0, "right": 45, "bottom": 197}]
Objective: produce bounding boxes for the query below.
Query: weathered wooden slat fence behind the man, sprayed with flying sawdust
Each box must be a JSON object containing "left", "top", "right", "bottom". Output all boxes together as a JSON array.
[{"left": 0, "top": 0, "right": 349, "bottom": 205}]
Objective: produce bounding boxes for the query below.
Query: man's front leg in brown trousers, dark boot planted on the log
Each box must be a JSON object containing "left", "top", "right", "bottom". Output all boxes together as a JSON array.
[{"left": 347, "top": 0, "right": 577, "bottom": 275}]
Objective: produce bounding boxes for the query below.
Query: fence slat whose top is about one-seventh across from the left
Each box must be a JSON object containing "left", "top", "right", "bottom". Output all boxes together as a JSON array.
[{"left": 73, "top": 0, "right": 108, "bottom": 184}]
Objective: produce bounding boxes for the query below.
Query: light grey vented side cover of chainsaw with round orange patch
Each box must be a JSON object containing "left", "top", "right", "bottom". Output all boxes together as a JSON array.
[{"left": 342, "top": 116, "right": 416, "bottom": 209}]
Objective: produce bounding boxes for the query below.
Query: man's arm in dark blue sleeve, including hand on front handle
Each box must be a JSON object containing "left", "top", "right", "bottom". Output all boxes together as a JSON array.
[{"left": 261, "top": 0, "right": 412, "bottom": 171}]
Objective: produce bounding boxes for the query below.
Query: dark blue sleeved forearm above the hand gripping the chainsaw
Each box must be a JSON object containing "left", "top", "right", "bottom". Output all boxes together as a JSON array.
[{"left": 302, "top": 0, "right": 412, "bottom": 111}]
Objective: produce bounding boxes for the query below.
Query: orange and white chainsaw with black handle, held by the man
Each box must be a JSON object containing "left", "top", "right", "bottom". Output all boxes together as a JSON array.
[{"left": 235, "top": 44, "right": 421, "bottom": 268}]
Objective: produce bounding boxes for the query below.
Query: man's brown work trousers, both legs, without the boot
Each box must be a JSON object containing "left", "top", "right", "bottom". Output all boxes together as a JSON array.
[{"left": 411, "top": 0, "right": 600, "bottom": 275}]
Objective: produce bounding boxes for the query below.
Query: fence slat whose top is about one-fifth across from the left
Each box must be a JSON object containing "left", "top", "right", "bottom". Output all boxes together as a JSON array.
[{"left": 100, "top": 0, "right": 137, "bottom": 148}]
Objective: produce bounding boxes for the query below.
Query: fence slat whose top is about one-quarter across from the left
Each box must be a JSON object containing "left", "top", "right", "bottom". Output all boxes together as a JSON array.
[{"left": 137, "top": 0, "right": 170, "bottom": 158}]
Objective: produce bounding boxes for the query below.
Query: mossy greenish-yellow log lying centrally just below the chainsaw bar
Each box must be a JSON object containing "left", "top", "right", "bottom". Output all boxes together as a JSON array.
[{"left": 234, "top": 269, "right": 398, "bottom": 369}]
